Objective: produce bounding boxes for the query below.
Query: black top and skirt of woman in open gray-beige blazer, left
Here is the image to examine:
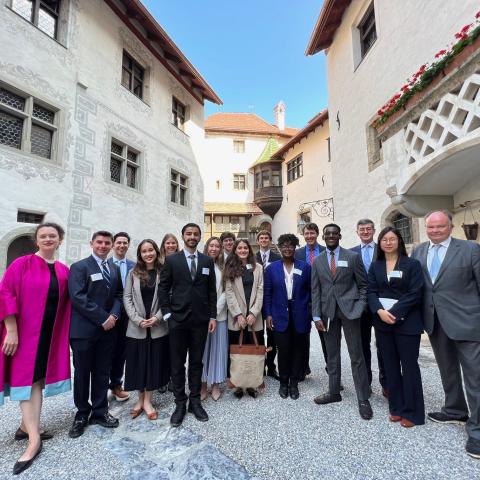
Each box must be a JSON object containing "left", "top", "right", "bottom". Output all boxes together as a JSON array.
[{"left": 124, "top": 270, "right": 170, "bottom": 392}]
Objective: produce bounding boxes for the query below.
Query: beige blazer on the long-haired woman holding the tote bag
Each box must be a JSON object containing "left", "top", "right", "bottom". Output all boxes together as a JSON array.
[{"left": 225, "top": 263, "right": 263, "bottom": 332}]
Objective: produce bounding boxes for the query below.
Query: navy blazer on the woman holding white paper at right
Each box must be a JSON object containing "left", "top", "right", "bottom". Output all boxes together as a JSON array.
[{"left": 367, "top": 256, "right": 423, "bottom": 335}]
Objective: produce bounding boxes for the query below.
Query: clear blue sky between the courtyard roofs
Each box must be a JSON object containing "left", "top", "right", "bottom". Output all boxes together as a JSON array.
[{"left": 143, "top": 0, "right": 327, "bottom": 128}]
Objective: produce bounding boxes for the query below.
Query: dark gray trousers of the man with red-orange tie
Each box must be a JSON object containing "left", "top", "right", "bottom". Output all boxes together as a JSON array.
[{"left": 324, "top": 307, "right": 370, "bottom": 402}]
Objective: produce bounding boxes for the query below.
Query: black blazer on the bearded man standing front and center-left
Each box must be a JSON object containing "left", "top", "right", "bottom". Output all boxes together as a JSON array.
[{"left": 158, "top": 251, "right": 217, "bottom": 322}]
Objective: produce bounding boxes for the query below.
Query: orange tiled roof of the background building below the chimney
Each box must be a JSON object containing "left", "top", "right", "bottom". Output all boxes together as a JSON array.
[{"left": 205, "top": 113, "right": 298, "bottom": 137}]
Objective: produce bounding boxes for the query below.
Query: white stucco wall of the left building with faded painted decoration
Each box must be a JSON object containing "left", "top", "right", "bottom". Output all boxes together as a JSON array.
[{"left": 0, "top": 0, "right": 204, "bottom": 269}]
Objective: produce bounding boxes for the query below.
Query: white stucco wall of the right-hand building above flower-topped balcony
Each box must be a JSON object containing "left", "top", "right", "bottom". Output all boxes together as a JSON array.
[{"left": 327, "top": 0, "right": 478, "bottom": 244}]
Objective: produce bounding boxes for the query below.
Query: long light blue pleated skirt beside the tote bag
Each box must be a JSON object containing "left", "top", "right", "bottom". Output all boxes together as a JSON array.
[{"left": 202, "top": 320, "right": 228, "bottom": 385}]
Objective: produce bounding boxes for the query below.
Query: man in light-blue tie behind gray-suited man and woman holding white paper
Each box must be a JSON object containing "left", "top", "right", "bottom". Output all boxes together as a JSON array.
[{"left": 350, "top": 218, "right": 388, "bottom": 397}]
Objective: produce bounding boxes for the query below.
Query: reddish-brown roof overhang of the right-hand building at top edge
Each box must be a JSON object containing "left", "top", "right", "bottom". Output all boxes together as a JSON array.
[{"left": 305, "top": 0, "right": 352, "bottom": 55}]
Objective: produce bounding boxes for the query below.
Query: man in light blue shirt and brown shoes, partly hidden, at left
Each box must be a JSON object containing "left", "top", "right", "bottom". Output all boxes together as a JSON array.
[{"left": 108, "top": 232, "right": 135, "bottom": 402}]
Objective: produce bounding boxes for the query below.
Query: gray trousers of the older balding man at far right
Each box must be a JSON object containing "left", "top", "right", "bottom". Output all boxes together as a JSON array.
[{"left": 430, "top": 315, "right": 480, "bottom": 440}]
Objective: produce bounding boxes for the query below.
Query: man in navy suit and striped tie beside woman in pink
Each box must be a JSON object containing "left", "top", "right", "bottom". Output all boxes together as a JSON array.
[{"left": 68, "top": 230, "right": 123, "bottom": 438}]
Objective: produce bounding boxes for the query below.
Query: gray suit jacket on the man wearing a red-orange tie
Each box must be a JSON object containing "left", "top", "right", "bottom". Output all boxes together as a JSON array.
[{"left": 312, "top": 248, "right": 367, "bottom": 322}]
